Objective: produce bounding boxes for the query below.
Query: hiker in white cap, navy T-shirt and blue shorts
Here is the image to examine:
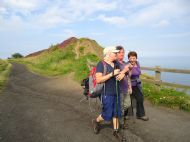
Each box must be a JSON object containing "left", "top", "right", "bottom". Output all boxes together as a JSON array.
[{"left": 92, "top": 47, "right": 121, "bottom": 137}]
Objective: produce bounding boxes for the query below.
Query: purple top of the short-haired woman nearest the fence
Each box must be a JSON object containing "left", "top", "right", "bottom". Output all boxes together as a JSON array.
[{"left": 131, "top": 65, "right": 141, "bottom": 86}]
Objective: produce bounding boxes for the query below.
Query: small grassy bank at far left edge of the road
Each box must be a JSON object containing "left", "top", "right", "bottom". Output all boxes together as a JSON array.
[{"left": 0, "top": 59, "right": 11, "bottom": 91}]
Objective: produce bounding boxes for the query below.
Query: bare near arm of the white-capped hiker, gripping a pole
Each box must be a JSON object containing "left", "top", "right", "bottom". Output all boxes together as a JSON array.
[{"left": 96, "top": 69, "right": 120, "bottom": 83}]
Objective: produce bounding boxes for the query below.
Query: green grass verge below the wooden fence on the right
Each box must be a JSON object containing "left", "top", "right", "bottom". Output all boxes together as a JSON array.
[{"left": 143, "top": 83, "right": 190, "bottom": 111}]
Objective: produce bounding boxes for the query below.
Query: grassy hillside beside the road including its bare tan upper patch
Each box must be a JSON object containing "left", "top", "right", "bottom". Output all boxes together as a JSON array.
[{"left": 14, "top": 38, "right": 102, "bottom": 81}]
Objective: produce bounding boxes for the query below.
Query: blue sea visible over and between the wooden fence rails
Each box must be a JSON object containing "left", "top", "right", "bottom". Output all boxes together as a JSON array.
[{"left": 132, "top": 56, "right": 190, "bottom": 95}]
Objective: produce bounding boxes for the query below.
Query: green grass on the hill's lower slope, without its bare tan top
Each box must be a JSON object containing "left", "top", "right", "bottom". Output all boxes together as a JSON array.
[{"left": 12, "top": 45, "right": 99, "bottom": 81}]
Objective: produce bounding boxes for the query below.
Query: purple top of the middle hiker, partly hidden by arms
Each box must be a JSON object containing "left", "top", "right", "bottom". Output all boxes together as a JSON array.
[{"left": 118, "top": 61, "right": 128, "bottom": 93}]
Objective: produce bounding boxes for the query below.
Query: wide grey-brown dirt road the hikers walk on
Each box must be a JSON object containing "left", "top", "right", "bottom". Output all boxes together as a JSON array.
[{"left": 0, "top": 64, "right": 190, "bottom": 142}]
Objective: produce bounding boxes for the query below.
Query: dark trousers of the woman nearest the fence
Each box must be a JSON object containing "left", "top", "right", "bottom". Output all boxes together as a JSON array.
[{"left": 132, "top": 86, "right": 145, "bottom": 117}]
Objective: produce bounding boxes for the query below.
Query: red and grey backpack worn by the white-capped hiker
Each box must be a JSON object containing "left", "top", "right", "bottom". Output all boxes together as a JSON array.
[{"left": 82, "top": 61, "right": 107, "bottom": 98}]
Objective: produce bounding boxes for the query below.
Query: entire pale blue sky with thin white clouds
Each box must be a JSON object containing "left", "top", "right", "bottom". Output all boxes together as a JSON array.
[{"left": 0, "top": 0, "right": 190, "bottom": 59}]
